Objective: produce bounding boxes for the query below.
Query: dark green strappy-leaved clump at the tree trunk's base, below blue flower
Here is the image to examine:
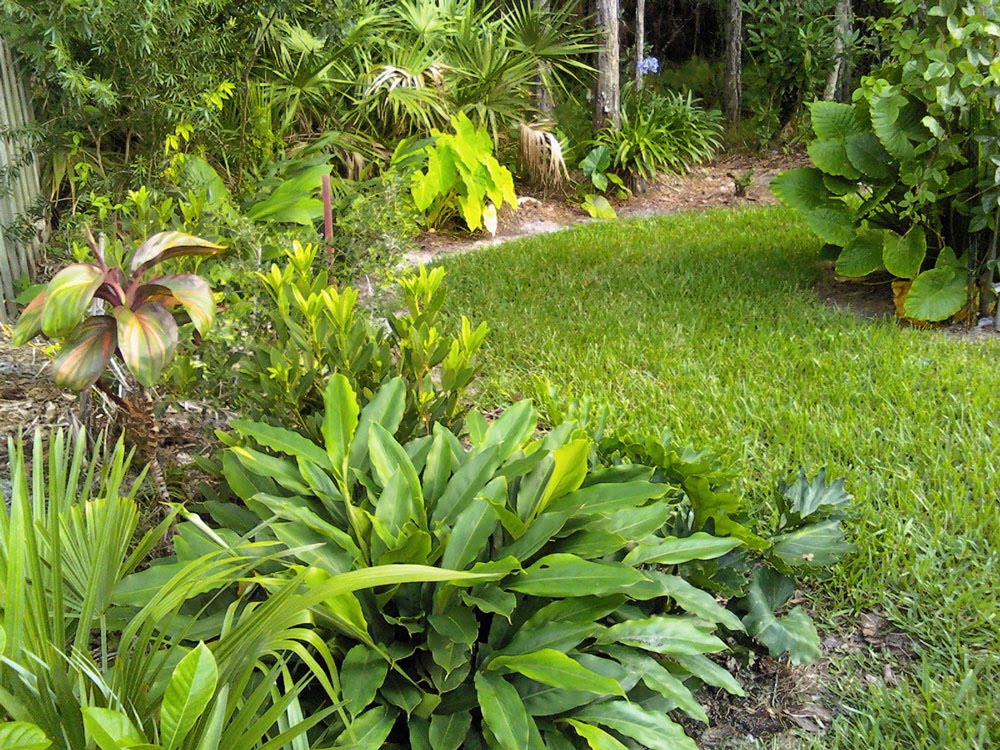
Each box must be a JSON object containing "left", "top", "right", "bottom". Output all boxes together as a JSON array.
[{"left": 597, "top": 92, "right": 722, "bottom": 180}]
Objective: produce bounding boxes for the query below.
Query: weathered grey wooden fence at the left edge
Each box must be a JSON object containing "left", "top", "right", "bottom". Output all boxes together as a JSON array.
[{"left": 0, "top": 39, "right": 42, "bottom": 323}]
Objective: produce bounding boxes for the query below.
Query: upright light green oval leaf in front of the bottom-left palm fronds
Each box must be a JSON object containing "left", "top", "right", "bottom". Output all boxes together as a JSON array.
[{"left": 160, "top": 643, "right": 219, "bottom": 750}]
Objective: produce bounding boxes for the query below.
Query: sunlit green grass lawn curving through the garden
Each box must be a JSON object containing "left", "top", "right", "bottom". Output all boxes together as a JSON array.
[{"left": 438, "top": 208, "right": 1000, "bottom": 748}]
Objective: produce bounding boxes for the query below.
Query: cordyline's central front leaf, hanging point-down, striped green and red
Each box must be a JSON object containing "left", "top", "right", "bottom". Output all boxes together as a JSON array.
[{"left": 114, "top": 302, "right": 177, "bottom": 388}]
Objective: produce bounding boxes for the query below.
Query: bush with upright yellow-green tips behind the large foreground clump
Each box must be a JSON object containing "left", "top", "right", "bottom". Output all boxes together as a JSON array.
[{"left": 239, "top": 244, "right": 487, "bottom": 446}]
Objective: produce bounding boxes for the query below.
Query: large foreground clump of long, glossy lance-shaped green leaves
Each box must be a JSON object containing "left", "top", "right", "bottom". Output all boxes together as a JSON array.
[{"left": 224, "top": 375, "right": 856, "bottom": 749}]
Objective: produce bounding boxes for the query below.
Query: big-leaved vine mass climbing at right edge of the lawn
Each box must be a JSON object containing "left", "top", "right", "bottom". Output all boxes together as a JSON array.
[{"left": 773, "top": 1, "right": 1000, "bottom": 321}]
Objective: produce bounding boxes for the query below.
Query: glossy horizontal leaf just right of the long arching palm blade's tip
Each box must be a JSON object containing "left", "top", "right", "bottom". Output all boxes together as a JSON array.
[{"left": 508, "top": 554, "right": 645, "bottom": 598}]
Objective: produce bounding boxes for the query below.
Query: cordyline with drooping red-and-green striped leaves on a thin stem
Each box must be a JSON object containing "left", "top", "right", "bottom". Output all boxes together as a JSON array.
[{"left": 12, "top": 230, "right": 224, "bottom": 500}]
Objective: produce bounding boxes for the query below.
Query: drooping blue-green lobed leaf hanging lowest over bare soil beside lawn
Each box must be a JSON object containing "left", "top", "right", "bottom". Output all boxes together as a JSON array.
[{"left": 743, "top": 568, "right": 822, "bottom": 664}]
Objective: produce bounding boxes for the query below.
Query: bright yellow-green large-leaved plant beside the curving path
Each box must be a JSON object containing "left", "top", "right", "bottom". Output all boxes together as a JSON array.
[{"left": 397, "top": 114, "right": 517, "bottom": 232}]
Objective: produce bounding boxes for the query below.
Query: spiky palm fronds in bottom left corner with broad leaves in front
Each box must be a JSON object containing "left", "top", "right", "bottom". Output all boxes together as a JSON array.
[{"left": 0, "top": 432, "right": 490, "bottom": 750}]
